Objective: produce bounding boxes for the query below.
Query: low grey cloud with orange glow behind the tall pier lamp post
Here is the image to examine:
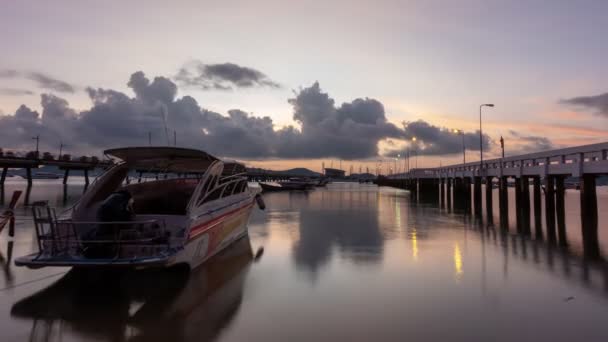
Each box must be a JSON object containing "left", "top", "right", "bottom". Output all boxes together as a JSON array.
[{"left": 386, "top": 120, "right": 493, "bottom": 157}]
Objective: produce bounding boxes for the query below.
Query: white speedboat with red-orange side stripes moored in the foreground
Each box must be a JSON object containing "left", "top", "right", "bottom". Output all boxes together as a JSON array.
[{"left": 15, "top": 147, "right": 264, "bottom": 269}]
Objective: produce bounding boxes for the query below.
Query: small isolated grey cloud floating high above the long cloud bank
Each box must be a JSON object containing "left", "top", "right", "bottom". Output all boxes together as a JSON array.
[{"left": 175, "top": 61, "right": 281, "bottom": 90}]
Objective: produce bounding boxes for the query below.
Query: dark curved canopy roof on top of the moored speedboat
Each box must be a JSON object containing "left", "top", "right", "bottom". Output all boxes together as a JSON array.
[{"left": 104, "top": 146, "right": 219, "bottom": 173}]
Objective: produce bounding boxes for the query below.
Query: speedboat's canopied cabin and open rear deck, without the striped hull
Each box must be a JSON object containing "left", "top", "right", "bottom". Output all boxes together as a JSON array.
[{"left": 27, "top": 147, "right": 252, "bottom": 264}]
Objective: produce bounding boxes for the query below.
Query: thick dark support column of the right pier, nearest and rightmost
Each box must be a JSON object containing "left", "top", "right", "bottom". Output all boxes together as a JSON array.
[{"left": 580, "top": 175, "right": 600, "bottom": 258}]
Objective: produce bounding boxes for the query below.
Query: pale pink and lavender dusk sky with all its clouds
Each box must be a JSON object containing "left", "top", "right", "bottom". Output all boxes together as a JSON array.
[{"left": 0, "top": 0, "right": 608, "bottom": 173}]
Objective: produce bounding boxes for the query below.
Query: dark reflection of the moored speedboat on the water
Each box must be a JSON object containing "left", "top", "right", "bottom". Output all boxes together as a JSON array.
[{"left": 11, "top": 238, "right": 253, "bottom": 341}]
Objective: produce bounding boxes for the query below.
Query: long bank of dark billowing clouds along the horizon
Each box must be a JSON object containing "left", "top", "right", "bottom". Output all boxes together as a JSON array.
[{"left": 0, "top": 71, "right": 524, "bottom": 160}]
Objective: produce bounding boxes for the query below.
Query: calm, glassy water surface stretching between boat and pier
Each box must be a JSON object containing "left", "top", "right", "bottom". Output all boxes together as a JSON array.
[{"left": 0, "top": 181, "right": 608, "bottom": 342}]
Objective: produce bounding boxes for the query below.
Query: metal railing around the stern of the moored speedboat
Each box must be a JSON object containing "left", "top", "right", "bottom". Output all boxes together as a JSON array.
[{"left": 33, "top": 207, "right": 171, "bottom": 260}]
